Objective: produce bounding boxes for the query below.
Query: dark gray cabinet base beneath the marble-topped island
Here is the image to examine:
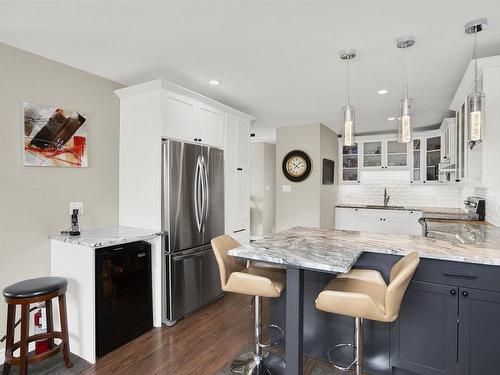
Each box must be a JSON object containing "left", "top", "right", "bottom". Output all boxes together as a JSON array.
[{"left": 271, "top": 253, "right": 500, "bottom": 375}]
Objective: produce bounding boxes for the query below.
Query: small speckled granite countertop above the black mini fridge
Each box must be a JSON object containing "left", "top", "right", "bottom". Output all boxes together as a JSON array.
[{"left": 49, "top": 226, "right": 161, "bottom": 248}]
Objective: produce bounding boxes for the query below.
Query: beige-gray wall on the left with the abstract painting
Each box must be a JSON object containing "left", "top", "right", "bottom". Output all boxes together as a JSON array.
[{"left": 0, "top": 44, "right": 121, "bottom": 356}]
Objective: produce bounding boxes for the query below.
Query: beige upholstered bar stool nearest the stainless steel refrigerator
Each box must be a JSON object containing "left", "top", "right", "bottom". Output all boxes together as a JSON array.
[{"left": 212, "top": 235, "right": 286, "bottom": 375}]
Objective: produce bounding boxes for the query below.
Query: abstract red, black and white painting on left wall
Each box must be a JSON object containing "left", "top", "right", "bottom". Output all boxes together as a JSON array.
[{"left": 23, "top": 103, "right": 87, "bottom": 168}]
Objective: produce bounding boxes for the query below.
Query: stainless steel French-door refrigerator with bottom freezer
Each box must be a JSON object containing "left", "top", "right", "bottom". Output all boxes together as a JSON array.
[{"left": 162, "top": 140, "right": 224, "bottom": 325}]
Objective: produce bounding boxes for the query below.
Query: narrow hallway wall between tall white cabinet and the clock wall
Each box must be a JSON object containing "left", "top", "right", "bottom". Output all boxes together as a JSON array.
[{"left": 250, "top": 142, "right": 276, "bottom": 238}]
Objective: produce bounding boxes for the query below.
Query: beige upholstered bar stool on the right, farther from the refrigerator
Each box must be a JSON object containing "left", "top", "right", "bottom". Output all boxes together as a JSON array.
[{"left": 316, "top": 252, "right": 420, "bottom": 375}]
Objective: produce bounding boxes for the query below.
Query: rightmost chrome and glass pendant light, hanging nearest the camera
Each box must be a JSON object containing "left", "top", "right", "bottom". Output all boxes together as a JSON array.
[{"left": 465, "top": 18, "right": 488, "bottom": 148}]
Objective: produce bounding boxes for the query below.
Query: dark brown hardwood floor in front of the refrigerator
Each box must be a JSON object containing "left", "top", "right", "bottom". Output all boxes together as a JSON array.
[{"left": 82, "top": 293, "right": 345, "bottom": 375}]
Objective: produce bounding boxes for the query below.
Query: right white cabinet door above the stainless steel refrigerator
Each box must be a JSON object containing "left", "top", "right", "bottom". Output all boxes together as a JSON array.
[{"left": 195, "top": 104, "right": 224, "bottom": 148}]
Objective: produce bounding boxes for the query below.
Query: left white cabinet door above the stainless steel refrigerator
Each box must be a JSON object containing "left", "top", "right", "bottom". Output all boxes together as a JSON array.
[{"left": 161, "top": 92, "right": 196, "bottom": 142}]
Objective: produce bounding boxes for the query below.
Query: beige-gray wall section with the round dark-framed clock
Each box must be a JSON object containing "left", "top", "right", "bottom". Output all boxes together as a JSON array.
[{"left": 276, "top": 124, "right": 338, "bottom": 232}]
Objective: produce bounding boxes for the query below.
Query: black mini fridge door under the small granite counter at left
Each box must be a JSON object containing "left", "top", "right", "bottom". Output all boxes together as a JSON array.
[{"left": 96, "top": 241, "right": 153, "bottom": 356}]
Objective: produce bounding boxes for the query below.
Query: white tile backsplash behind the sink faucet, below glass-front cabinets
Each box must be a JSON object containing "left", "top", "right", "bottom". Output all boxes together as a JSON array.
[{"left": 340, "top": 170, "right": 463, "bottom": 208}]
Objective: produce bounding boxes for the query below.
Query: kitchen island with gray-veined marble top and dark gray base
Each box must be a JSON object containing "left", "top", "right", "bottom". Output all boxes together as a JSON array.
[{"left": 230, "top": 227, "right": 500, "bottom": 375}]
